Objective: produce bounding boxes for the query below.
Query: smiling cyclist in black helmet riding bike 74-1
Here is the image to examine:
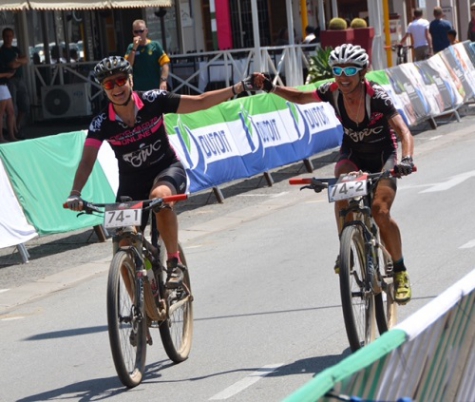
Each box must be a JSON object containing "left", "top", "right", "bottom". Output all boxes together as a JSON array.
[{"left": 66, "top": 56, "right": 251, "bottom": 288}]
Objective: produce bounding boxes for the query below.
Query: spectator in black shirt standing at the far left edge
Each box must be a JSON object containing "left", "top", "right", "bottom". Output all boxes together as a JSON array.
[{"left": 0, "top": 28, "right": 30, "bottom": 135}]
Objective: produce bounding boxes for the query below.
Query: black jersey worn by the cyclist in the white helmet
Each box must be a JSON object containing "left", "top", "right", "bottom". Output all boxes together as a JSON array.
[{"left": 316, "top": 80, "right": 398, "bottom": 154}]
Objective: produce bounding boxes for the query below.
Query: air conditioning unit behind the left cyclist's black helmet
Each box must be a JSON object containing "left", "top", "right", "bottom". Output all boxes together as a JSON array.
[{"left": 41, "top": 82, "right": 92, "bottom": 120}]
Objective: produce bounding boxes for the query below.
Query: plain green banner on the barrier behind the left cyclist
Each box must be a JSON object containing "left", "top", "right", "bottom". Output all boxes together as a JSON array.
[{"left": 0, "top": 131, "right": 115, "bottom": 235}]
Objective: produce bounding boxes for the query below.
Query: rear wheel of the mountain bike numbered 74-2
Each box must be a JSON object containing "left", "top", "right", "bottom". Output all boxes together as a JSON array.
[{"left": 375, "top": 247, "right": 397, "bottom": 335}]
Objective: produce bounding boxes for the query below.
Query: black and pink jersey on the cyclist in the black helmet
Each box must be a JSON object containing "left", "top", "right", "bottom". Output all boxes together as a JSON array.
[{"left": 86, "top": 89, "right": 180, "bottom": 175}]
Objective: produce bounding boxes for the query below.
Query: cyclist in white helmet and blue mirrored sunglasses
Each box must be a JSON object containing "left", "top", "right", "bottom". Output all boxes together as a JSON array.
[{"left": 251, "top": 44, "right": 414, "bottom": 304}]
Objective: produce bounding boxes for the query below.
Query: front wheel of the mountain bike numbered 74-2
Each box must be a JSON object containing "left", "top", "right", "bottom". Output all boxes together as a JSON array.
[{"left": 340, "top": 226, "right": 376, "bottom": 352}]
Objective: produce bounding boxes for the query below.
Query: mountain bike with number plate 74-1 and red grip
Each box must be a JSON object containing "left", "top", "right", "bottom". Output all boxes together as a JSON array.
[{"left": 64, "top": 194, "right": 193, "bottom": 388}]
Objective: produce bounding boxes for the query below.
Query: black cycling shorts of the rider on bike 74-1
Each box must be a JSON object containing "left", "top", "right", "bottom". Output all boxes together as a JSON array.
[{"left": 116, "top": 162, "right": 187, "bottom": 201}]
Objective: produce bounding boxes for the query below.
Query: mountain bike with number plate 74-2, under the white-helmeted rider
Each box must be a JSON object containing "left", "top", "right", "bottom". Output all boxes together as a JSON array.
[{"left": 289, "top": 169, "right": 410, "bottom": 352}]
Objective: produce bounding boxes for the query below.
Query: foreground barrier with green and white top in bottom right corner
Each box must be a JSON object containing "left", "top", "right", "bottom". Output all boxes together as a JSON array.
[{"left": 285, "top": 270, "right": 475, "bottom": 402}]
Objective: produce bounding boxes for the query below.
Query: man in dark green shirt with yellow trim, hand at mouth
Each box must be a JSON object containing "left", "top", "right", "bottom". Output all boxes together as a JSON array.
[{"left": 125, "top": 20, "right": 170, "bottom": 91}]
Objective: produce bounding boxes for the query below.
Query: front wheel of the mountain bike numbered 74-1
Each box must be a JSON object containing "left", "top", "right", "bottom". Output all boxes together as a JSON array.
[{"left": 107, "top": 250, "right": 147, "bottom": 388}]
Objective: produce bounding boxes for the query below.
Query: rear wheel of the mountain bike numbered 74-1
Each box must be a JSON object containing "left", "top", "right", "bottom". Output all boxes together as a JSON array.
[{"left": 159, "top": 240, "right": 193, "bottom": 363}]
